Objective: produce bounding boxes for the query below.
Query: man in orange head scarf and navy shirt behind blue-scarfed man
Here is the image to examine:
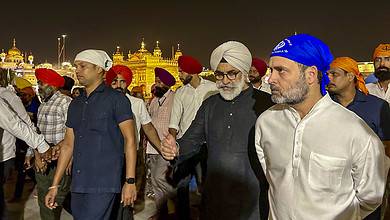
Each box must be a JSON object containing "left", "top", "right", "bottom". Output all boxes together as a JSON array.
[{"left": 328, "top": 57, "right": 390, "bottom": 220}]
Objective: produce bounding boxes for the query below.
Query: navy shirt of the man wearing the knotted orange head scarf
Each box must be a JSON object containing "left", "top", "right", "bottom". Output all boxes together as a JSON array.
[{"left": 332, "top": 90, "right": 390, "bottom": 141}]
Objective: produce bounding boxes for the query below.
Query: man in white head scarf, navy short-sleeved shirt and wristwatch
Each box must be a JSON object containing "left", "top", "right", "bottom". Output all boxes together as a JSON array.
[{"left": 45, "top": 50, "right": 136, "bottom": 220}]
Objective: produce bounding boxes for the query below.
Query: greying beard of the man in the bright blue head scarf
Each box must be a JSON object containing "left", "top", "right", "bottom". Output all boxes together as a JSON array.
[{"left": 271, "top": 73, "right": 309, "bottom": 105}]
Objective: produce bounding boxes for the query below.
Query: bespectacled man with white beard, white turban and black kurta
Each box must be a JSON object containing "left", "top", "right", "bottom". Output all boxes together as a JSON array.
[{"left": 162, "top": 41, "right": 273, "bottom": 220}]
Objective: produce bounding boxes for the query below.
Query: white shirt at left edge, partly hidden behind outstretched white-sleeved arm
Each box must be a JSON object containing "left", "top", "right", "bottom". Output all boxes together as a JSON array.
[{"left": 0, "top": 87, "right": 35, "bottom": 162}]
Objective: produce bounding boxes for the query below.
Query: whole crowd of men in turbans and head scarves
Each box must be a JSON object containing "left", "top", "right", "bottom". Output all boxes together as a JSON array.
[{"left": 0, "top": 34, "right": 390, "bottom": 220}]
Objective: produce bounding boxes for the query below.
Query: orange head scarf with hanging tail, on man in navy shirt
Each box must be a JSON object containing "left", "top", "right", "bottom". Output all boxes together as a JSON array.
[{"left": 330, "top": 57, "right": 368, "bottom": 95}]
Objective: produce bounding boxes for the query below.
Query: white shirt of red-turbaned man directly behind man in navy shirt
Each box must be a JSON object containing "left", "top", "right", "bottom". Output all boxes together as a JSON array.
[{"left": 126, "top": 94, "right": 152, "bottom": 148}]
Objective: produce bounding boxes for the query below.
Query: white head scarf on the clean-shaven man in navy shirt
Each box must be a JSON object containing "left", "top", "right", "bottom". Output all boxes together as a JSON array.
[{"left": 74, "top": 49, "right": 112, "bottom": 71}]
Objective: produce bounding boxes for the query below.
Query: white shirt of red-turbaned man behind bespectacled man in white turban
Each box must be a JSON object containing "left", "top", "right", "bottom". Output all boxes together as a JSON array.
[{"left": 169, "top": 78, "right": 218, "bottom": 138}]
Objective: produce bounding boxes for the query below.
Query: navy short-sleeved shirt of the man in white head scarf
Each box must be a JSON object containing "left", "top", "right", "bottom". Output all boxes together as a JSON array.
[{"left": 66, "top": 84, "right": 133, "bottom": 193}]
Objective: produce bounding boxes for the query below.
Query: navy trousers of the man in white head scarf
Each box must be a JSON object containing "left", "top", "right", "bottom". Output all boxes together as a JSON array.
[{"left": 71, "top": 192, "right": 117, "bottom": 220}]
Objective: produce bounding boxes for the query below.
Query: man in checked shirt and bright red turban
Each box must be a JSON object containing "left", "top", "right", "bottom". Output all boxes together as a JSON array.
[{"left": 27, "top": 68, "right": 72, "bottom": 220}]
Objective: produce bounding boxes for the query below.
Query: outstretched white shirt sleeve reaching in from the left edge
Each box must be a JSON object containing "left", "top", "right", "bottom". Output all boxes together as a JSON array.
[{"left": 0, "top": 98, "right": 49, "bottom": 153}]
